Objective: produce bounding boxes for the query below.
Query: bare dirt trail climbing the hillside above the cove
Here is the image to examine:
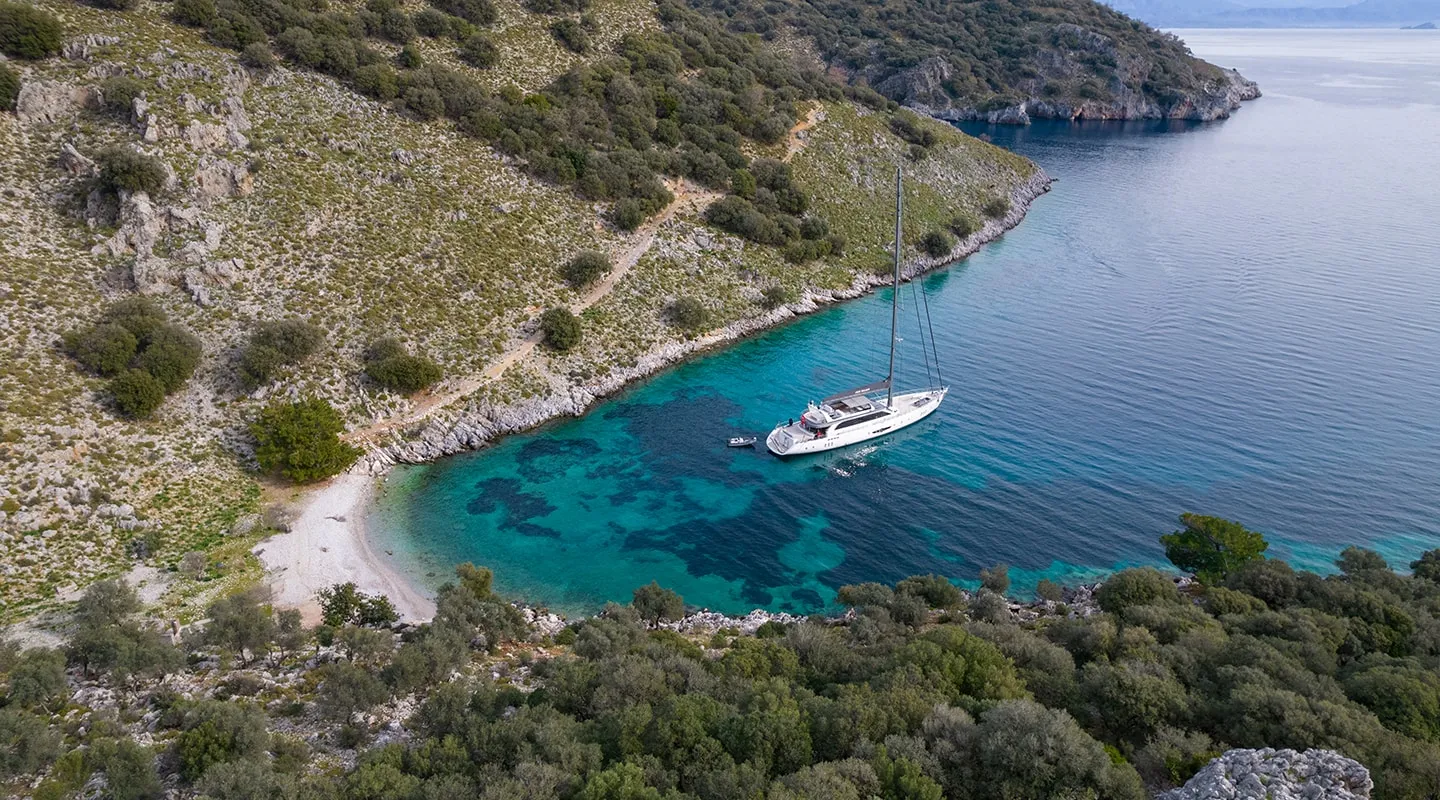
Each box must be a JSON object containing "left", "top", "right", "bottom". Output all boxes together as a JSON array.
[{"left": 344, "top": 104, "right": 825, "bottom": 445}]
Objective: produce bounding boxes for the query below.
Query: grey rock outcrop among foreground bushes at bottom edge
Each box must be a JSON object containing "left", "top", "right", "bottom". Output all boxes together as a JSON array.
[{"left": 1156, "top": 747, "right": 1375, "bottom": 800}]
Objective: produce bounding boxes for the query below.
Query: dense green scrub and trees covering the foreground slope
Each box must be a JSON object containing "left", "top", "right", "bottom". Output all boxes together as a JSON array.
[{"left": 0, "top": 515, "right": 1440, "bottom": 800}]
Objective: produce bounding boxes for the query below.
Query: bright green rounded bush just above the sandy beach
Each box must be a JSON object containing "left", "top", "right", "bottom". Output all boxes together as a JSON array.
[{"left": 251, "top": 397, "right": 360, "bottom": 483}]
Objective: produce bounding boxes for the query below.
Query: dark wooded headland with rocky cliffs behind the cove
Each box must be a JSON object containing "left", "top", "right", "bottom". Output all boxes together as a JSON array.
[{"left": 694, "top": 0, "right": 1259, "bottom": 124}]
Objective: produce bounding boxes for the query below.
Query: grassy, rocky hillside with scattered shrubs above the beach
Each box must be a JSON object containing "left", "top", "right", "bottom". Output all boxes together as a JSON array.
[{"left": 0, "top": 0, "right": 1045, "bottom": 619}]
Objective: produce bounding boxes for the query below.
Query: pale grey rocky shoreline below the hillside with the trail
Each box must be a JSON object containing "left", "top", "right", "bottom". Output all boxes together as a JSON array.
[{"left": 362, "top": 167, "right": 1051, "bottom": 475}]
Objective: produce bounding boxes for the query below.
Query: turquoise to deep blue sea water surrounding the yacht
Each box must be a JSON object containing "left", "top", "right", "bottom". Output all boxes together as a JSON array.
[{"left": 372, "top": 32, "right": 1440, "bottom": 612}]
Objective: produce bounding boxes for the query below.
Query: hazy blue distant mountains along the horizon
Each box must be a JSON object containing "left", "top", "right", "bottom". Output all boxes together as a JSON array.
[{"left": 1110, "top": 0, "right": 1440, "bottom": 27}]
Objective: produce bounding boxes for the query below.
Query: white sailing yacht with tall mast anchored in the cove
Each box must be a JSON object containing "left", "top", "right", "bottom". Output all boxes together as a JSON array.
[{"left": 765, "top": 168, "right": 950, "bottom": 456}]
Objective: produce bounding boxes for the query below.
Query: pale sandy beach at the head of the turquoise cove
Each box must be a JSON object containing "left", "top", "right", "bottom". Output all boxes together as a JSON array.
[{"left": 255, "top": 473, "right": 435, "bottom": 624}]
